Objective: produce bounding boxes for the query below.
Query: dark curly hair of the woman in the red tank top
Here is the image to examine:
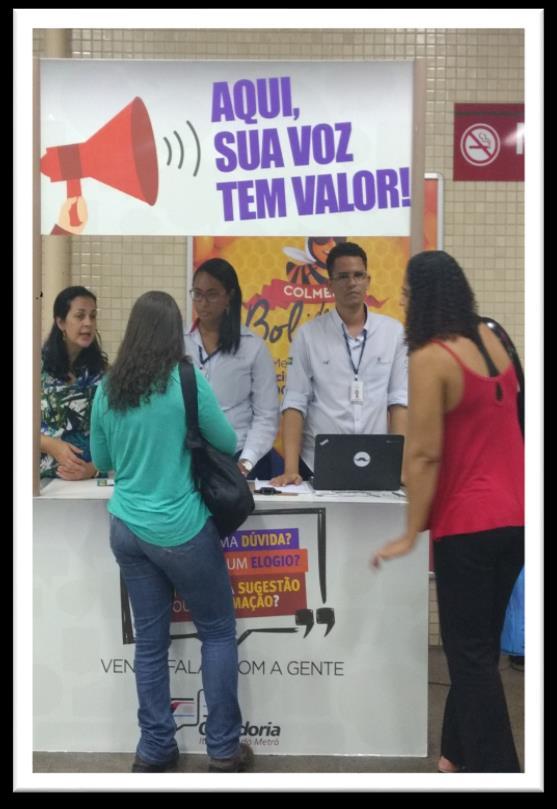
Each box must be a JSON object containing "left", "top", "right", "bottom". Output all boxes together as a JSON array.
[{"left": 405, "top": 250, "right": 479, "bottom": 352}]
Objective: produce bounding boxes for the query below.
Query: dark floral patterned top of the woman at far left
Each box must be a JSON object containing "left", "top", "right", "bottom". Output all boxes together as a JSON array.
[{"left": 40, "top": 369, "right": 103, "bottom": 478}]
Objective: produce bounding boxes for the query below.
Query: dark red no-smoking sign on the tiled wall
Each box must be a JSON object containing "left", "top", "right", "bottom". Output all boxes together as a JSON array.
[{"left": 453, "top": 104, "right": 524, "bottom": 182}]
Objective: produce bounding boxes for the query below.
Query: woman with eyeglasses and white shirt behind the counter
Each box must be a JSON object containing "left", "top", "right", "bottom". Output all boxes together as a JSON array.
[{"left": 185, "top": 258, "right": 279, "bottom": 480}]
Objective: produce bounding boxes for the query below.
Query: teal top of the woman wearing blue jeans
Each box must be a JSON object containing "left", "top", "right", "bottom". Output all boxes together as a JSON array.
[{"left": 91, "top": 365, "right": 236, "bottom": 547}]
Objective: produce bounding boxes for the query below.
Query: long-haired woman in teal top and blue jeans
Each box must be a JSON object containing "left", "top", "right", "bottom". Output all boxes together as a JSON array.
[{"left": 91, "top": 292, "right": 252, "bottom": 772}]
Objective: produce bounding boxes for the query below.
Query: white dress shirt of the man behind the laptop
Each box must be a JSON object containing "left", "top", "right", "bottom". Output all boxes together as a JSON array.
[{"left": 281, "top": 309, "right": 408, "bottom": 469}]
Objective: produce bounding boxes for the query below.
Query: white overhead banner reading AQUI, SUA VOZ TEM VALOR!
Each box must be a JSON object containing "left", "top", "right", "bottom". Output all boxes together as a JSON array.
[{"left": 40, "top": 59, "right": 413, "bottom": 236}]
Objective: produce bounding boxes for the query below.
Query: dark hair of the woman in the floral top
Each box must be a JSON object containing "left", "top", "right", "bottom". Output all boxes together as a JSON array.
[{"left": 42, "top": 286, "right": 108, "bottom": 380}]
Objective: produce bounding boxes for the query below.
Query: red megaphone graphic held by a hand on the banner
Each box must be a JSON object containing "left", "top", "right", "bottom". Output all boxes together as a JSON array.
[{"left": 41, "top": 98, "right": 159, "bottom": 225}]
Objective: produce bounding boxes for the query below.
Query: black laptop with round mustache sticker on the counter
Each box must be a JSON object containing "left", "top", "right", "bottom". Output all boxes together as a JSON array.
[{"left": 313, "top": 434, "right": 404, "bottom": 491}]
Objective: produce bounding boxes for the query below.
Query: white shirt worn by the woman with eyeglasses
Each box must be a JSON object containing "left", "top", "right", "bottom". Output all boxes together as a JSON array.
[{"left": 184, "top": 326, "right": 279, "bottom": 465}]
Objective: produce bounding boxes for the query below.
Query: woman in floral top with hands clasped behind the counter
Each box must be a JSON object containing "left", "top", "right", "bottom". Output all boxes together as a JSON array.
[{"left": 40, "top": 286, "right": 108, "bottom": 480}]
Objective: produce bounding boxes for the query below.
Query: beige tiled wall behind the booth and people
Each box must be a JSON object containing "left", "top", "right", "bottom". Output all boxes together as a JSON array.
[{"left": 34, "top": 29, "right": 524, "bottom": 644}]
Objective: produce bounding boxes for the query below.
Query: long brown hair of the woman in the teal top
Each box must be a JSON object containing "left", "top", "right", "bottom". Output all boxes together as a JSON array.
[{"left": 105, "top": 291, "right": 184, "bottom": 410}]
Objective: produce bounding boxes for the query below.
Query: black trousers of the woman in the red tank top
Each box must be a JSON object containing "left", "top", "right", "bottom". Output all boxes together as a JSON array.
[{"left": 433, "top": 527, "right": 524, "bottom": 772}]
